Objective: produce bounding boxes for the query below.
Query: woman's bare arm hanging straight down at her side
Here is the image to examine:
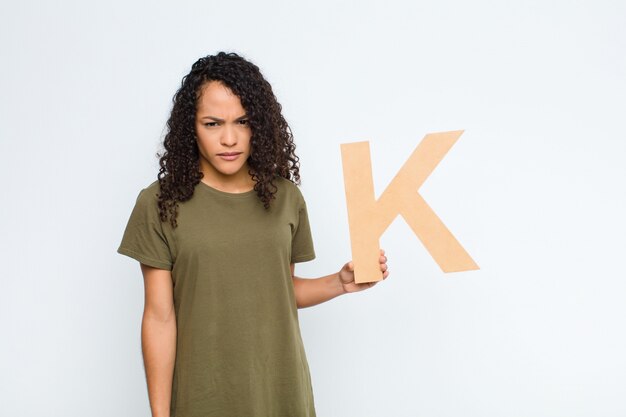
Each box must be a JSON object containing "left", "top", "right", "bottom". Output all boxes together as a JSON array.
[{"left": 141, "top": 264, "right": 176, "bottom": 417}]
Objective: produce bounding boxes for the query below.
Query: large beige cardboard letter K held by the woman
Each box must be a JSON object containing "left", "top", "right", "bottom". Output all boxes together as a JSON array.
[{"left": 341, "top": 130, "right": 479, "bottom": 283}]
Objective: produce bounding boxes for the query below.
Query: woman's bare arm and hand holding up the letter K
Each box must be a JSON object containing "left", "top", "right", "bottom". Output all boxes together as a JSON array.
[{"left": 291, "top": 249, "right": 389, "bottom": 308}]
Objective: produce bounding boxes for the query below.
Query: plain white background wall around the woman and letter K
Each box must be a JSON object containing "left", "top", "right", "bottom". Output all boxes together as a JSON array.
[{"left": 0, "top": 0, "right": 626, "bottom": 417}]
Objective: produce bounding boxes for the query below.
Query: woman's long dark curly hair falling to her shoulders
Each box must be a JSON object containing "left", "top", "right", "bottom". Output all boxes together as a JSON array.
[{"left": 157, "top": 52, "right": 300, "bottom": 228}]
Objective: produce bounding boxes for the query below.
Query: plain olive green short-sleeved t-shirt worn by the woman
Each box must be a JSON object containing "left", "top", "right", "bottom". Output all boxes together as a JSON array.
[{"left": 117, "top": 177, "right": 315, "bottom": 417}]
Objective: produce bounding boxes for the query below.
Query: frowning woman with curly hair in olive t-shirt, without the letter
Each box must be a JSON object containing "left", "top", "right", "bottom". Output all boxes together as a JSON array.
[{"left": 118, "top": 52, "right": 389, "bottom": 417}]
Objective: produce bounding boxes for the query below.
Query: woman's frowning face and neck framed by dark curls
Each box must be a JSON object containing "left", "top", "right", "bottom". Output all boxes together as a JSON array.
[{"left": 195, "top": 81, "right": 252, "bottom": 186}]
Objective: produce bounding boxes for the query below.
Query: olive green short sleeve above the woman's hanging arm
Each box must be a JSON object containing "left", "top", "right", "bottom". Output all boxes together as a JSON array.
[{"left": 117, "top": 188, "right": 173, "bottom": 271}]
